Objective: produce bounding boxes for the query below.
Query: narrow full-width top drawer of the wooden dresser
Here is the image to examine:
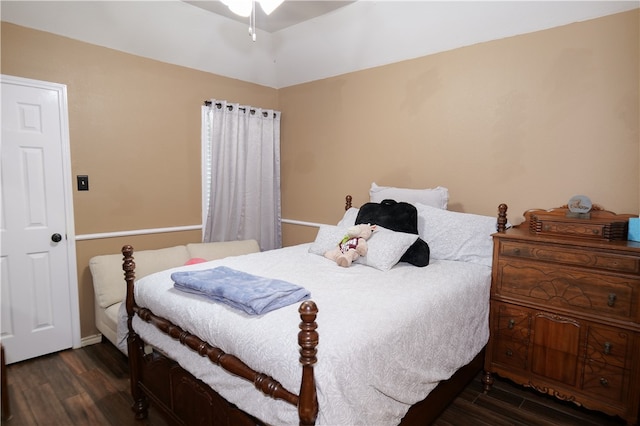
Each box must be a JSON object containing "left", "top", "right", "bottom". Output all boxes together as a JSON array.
[{"left": 500, "top": 241, "right": 640, "bottom": 275}]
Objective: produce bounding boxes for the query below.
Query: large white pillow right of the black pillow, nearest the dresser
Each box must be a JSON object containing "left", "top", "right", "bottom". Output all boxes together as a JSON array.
[{"left": 416, "top": 204, "right": 498, "bottom": 267}]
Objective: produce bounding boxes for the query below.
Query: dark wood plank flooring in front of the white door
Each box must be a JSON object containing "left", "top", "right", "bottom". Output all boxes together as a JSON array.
[{"left": 2, "top": 342, "right": 166, "bottom": 426}]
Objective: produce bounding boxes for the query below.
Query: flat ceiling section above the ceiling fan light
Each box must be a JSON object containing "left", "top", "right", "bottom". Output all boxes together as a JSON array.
[{"left": 183, "top": 0, "right": 355, "bottom": 33}]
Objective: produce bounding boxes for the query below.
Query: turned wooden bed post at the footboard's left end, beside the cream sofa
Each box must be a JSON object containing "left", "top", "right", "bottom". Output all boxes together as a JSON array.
[{"left": 122, "top": 245, "right": 149, "bottom": 420}]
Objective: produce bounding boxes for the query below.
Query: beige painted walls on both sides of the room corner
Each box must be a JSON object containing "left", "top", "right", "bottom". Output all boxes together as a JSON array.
[{"left": 1, "top": 10, "right": 640, "bottom": 337}]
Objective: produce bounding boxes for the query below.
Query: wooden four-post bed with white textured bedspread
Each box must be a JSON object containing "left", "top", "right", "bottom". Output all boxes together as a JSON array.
[{"left": 122, "top": 190, "right": 507, "bottom": 425}]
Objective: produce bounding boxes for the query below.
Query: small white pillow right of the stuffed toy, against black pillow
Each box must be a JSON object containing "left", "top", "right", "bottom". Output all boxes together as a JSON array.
[{"left": 356, "top": 225, "right": 418, "bottom": 271}]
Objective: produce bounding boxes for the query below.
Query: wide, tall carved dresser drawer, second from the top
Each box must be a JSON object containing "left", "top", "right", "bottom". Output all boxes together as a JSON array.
[{"left": 492, "top": 259, "right": 640, "bottom": 321}]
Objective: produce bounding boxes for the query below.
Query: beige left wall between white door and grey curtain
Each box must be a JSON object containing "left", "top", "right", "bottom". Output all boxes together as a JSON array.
[{"left": 1, "top": 22, "right": 277, "bottom": 337}]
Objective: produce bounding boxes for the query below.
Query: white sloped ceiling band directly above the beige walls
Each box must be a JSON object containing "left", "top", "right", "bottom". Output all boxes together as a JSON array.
[{"left": 0, "top": 0, "right": 640, "bottom": 88}]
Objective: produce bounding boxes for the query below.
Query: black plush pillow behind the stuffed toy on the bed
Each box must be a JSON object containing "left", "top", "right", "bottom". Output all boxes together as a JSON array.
[{"left": 356, "top": 200, "right": 429, "bottom": 266}]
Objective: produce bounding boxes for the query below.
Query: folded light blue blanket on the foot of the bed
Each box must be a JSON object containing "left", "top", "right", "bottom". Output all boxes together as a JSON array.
[{"left": 171, "top": 266, "right": 311, "bottom": 315}]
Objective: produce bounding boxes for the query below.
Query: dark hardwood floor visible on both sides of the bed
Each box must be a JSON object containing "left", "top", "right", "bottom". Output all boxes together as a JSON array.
[{"left": 2, "top": 342, "right": 624, "bottom": 426}]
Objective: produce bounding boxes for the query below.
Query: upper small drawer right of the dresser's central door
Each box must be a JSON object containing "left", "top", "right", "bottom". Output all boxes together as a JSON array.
[{"left": 586, "top": 325, "right": 632, "bottom": 368}]
